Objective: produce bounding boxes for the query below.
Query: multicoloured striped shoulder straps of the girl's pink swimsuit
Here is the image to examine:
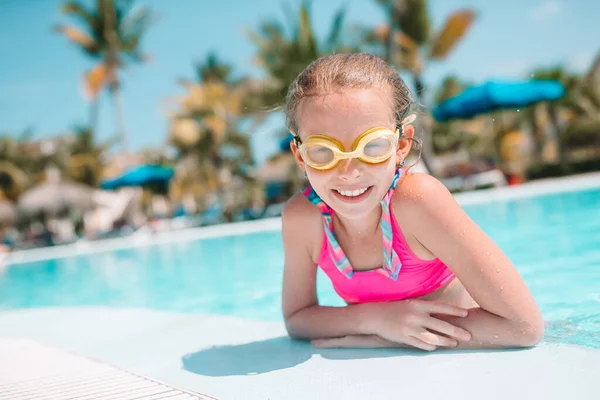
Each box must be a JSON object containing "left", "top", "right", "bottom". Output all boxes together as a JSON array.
[{"left": 303, "top": 169, "right": 402, "bottom": 280}]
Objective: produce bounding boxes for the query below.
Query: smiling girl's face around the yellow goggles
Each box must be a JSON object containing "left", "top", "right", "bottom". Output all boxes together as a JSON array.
[{"left": 291, "top": 88, "right": 413, "bottom": 219}]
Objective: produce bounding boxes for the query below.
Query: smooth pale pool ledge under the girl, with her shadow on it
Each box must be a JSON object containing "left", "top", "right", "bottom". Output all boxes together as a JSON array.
[{"left": 0, "top": 308, "right": 600, "bottom": 400}]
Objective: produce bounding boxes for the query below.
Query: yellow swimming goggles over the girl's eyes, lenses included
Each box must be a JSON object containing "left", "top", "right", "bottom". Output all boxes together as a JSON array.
[{"left": 294, "top": 127, "right": 400, "bottom": 170}]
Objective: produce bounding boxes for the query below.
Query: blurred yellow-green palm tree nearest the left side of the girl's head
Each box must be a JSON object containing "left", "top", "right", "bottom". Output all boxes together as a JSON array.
[{"left": 169, "top": 53, "right": 254, "bottom": 219}]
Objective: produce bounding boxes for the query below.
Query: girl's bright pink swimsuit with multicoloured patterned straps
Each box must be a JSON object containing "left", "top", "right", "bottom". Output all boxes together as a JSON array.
[{"left": 304, "top": 170, "right": 454, "bottom": 303}]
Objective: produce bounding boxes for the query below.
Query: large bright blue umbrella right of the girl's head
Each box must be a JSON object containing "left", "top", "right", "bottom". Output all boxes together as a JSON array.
[{"left": 433, "top": 79, "right": 565, "bottom": 122}]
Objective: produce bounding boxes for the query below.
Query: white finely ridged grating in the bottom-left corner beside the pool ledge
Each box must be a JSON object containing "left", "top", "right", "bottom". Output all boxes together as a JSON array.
[{"left": 0, "top": 337, "right": 215, "bottom": 400}]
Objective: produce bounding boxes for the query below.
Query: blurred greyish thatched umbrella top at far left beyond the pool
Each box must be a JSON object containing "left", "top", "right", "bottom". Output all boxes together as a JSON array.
[{"left": 17, "top": 182, "right": 95, "bottom": 218}]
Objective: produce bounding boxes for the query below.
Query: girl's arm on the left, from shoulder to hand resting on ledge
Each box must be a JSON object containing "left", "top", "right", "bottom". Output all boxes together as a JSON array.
[{"left": 282, "top": 192, "right": 470, "bottom": 350}]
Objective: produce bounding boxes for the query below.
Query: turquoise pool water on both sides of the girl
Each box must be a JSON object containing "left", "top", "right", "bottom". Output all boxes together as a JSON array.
[{"left": 0, "top": 188, "right": 600, "bottom": 348}]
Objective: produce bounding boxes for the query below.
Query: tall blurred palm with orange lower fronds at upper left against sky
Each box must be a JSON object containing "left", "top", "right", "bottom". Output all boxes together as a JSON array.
[{"left": 55, "top": 0, "right": 154, "bottom": 151}]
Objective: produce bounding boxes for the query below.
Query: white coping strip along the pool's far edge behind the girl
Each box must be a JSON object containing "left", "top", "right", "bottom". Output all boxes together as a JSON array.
[{"left": 0, "top": 172, "right": 600, "bottom": 266}]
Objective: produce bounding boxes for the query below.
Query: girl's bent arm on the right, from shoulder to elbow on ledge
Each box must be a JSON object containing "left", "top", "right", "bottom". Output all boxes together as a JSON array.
[{"left": 396, "top": 174, "right": 544, "bottom": 347}]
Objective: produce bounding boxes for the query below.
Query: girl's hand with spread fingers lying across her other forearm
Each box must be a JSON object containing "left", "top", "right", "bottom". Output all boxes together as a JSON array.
[{"left": 366, "top": 299, "right": 471, "bottom": 351}]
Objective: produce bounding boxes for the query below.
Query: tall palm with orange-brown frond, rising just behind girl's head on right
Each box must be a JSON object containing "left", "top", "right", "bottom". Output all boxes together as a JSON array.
[{"left": 363, "top": 0, "right": 475, "bottom": 170}]
